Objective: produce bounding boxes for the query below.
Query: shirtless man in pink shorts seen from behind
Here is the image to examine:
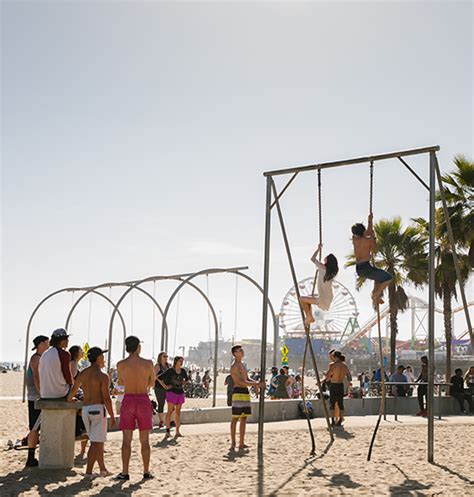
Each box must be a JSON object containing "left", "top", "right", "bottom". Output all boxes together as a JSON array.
[{"left": 116, "top": 336, "right": 155, "bottom": 480}]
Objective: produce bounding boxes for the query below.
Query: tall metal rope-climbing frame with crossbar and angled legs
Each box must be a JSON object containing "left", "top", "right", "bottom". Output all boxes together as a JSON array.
[{"left": 258, "top": 145, "right": 474, "bottom": 463}]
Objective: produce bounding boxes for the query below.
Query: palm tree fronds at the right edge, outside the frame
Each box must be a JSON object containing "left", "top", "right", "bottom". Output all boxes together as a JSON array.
[{"left": 438, "top": 155, "right": 474, "bottom": 268}]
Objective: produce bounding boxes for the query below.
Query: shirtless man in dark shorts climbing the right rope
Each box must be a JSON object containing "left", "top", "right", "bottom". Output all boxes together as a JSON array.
[{"left": 352, "top": 214, "right": 392, "bottom": 309}]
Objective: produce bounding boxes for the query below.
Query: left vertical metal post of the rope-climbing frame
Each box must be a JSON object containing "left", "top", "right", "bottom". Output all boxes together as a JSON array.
[{"left": 258, "top": 178, "right": 272, "bottom": 463}]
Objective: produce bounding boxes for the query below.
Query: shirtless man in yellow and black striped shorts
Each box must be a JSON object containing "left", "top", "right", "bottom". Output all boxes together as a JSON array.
[{"left": 230, "top": 345, "right": 265, "bottom": 452}]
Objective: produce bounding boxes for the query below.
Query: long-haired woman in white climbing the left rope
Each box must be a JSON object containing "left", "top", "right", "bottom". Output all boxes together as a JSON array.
[{"left": 300, "top": 244, "right": 339, "bottom": 326}]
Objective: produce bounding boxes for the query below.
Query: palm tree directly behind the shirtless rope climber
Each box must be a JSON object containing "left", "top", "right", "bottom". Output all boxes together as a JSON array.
[{"left": 346, "top": 217, "right": 428, "bottom": 372}]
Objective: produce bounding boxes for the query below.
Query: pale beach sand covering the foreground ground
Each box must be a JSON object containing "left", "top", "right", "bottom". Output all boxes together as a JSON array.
[{"left": 0, "top": 373, "right": 474, "bottom": 496}]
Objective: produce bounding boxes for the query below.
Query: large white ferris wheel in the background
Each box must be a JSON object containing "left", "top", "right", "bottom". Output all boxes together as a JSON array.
[{"left": 280, "top": 277, "right": 359, "bottom": 339}]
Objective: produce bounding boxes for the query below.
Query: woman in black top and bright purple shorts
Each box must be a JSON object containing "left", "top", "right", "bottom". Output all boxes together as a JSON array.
[{"left": 158, "top": 356, "right": 188, "bottom": 439}]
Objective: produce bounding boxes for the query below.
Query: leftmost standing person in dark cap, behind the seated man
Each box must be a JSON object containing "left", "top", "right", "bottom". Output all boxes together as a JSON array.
[{"left": 25, "top": 335, "right": 49, "bottom": 467}]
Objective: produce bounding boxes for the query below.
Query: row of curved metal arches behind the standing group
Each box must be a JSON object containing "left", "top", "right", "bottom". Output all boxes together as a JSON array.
[{"left": 23, "top": 268, "right": 279, "bottom": 407}]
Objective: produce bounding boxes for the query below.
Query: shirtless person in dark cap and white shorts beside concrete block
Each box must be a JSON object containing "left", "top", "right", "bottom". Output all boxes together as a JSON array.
[{"left": 67, "top": 347, "right": 115, "bottom": 478}]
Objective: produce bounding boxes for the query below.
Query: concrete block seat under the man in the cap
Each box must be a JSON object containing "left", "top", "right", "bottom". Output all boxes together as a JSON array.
[{"left": 35, "top": 399, "right": 82, "bottom": 469}]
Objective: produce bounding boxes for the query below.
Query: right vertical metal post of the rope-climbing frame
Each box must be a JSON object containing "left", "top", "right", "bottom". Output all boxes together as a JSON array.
[{"left": 427, "top": 152, "right": 436, "bottom": 462}]
